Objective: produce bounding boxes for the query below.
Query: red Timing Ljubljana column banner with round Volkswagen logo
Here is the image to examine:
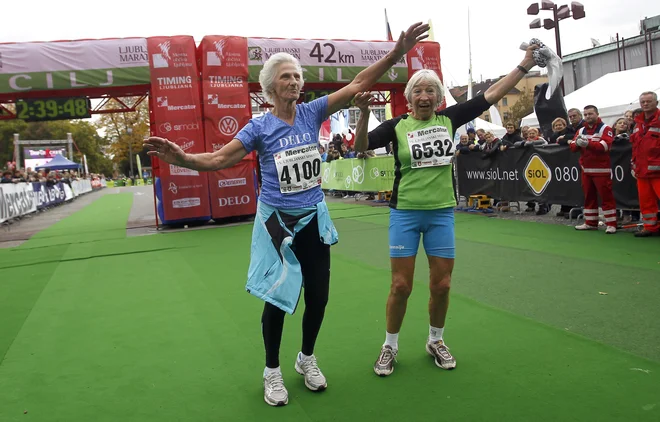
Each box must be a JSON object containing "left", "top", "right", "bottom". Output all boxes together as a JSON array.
[{"left": 198, "top": 36, "right": 257, "bottom": 218}]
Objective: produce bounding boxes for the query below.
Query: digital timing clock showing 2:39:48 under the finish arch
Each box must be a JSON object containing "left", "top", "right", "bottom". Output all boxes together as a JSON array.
[{"left": 16, "top": 97, "right": 91, "bottom": 122}]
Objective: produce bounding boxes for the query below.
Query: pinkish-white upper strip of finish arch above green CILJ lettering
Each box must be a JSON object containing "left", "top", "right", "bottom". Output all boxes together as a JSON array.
[{"left": 0, "top": 38, "right": 149, "bottom": 74}]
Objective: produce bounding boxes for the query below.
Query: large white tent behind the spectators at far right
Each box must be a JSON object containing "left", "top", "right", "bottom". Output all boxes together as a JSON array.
[{"left": 522, "top": 64, "right": 660, "bottom": 127}]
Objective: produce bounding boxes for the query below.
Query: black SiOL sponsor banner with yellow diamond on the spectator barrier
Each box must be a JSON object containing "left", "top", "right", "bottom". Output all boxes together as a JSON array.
[{"left": 457, "top": 144, "right": 639, "bottom": 209}]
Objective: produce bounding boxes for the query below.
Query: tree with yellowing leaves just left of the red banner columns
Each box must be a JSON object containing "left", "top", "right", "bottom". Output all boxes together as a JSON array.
[{"left": 96, "top": 97, "right": 151, "bottom": 174}]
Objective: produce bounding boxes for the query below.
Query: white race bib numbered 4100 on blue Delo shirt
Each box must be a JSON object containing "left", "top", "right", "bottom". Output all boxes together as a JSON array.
[{"left": 273, "top": 144, "right": 321, "bottom": 194}]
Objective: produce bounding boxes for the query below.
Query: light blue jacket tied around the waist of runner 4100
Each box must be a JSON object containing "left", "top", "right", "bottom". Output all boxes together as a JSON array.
[{"left": 245, "top": 201, "right": 339, "bottom": 314}]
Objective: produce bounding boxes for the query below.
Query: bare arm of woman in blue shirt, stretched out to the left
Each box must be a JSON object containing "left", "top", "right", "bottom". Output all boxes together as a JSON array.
[{"left": 144, "top": 136, "right": 247, "bottom": 171}]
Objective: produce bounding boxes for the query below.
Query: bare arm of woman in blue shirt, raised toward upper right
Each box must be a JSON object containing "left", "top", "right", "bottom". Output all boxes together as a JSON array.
[{"left": 326, "top": 22, "right": 429, "bottom": 117}]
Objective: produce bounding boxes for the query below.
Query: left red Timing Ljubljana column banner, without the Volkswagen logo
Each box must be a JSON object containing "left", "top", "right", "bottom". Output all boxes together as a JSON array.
[{"left": 147, "top": 36, "right": 211, "bottom": 224}]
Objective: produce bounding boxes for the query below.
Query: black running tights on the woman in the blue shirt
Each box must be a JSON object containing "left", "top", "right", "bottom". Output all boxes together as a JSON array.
[{"left": 261, "top": 217, "right": 330, "bottom": 368}]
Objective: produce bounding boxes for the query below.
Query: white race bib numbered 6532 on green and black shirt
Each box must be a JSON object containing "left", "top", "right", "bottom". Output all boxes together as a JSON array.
[{"left": 407, "top": 126, "right": 455, "bottom": 169}]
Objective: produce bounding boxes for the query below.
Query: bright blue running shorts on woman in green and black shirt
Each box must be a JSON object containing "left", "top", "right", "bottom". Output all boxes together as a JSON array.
[{"left": 390, "top": 208, "right": 456, "bottom": 259}]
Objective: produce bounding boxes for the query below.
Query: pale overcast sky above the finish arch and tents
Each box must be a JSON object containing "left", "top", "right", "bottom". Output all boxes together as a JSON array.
[{"left": 0, "top": 0, "right": 660, "bottom": 85}]
